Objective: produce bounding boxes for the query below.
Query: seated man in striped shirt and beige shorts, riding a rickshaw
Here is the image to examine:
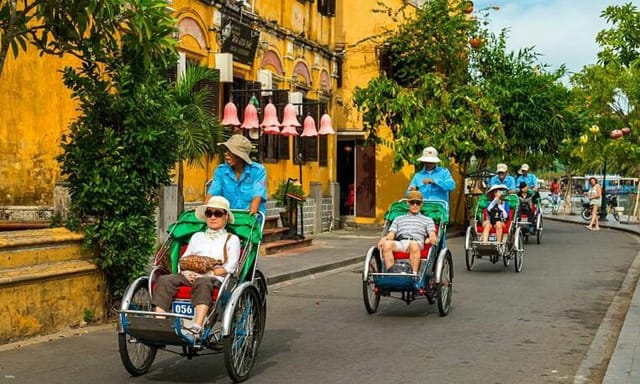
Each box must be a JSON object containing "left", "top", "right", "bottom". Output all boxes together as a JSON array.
[{"left": 378, "top": 191, "right": 438, "bottom": 273}]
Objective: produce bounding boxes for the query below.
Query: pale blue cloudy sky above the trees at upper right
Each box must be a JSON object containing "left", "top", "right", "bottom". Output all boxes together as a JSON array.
[{"left": 474, "top": 0, "right": 637, "bottom": 79}]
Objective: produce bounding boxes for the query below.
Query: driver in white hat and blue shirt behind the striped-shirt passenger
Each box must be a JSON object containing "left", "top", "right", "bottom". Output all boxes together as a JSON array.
[{"left": 407, "top": 147, "right": 456, "bottom": 207}]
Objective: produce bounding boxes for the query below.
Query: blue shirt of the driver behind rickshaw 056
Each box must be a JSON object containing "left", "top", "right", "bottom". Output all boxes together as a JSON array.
[{"left": 207, "top": 161, "right": 267, "bottom": 214}]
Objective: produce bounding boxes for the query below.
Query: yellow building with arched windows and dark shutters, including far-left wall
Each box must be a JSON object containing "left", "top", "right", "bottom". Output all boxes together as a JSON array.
[{"left": 0, "top": 0, "right": 462, "bottom": 228}]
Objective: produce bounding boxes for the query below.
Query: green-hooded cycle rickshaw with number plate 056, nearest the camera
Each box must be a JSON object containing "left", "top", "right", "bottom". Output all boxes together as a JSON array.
[{"left": 118, "top": 210, "right": 267, "bottom": 382}]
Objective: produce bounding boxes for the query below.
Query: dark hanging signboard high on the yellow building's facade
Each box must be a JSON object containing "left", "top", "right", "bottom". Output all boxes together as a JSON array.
[{"left": 222, "top": 19, "right": 260, "bottom": 66}]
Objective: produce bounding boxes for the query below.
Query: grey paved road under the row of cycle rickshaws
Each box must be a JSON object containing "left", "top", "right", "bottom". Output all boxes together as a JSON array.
[{"left": 0, "top": 222, "right": 637, "bottom": 384}]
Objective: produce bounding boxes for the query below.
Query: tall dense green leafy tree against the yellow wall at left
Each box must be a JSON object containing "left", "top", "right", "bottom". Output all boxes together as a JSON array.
[{"left": 55, "top": 0, "right": 182, "bottom": 297}]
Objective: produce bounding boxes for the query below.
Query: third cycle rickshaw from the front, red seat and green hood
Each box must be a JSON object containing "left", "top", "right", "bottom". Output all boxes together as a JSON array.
[{"left": 464, "top": 194, "right": 524, "bottom": 272}]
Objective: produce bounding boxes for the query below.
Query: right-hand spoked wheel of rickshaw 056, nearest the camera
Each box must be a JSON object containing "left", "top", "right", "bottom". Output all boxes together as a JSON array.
[{"left": 223, "top": 286, "right": 262, "bottom": 383}]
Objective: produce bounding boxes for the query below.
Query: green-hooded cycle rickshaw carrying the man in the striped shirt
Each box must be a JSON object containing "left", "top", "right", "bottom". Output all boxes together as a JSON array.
[{"left": 362, "top": 199, "right": 453, "bottom": 316}]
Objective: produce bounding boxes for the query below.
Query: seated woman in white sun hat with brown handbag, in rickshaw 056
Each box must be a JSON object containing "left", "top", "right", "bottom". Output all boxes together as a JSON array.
[{"left": 153, "top": 196, "right": 240, "bottom": 335}]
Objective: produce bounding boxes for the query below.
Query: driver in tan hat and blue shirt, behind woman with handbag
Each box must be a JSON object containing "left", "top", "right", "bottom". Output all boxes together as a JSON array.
[{"left": 205, "top": 134, "right": 267, "bottom": 214}]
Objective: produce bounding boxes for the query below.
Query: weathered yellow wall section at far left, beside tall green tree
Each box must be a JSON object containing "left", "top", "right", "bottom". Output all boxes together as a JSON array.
[{"left": 0, "top": 47, "right": 76, "bottom": 206}]
